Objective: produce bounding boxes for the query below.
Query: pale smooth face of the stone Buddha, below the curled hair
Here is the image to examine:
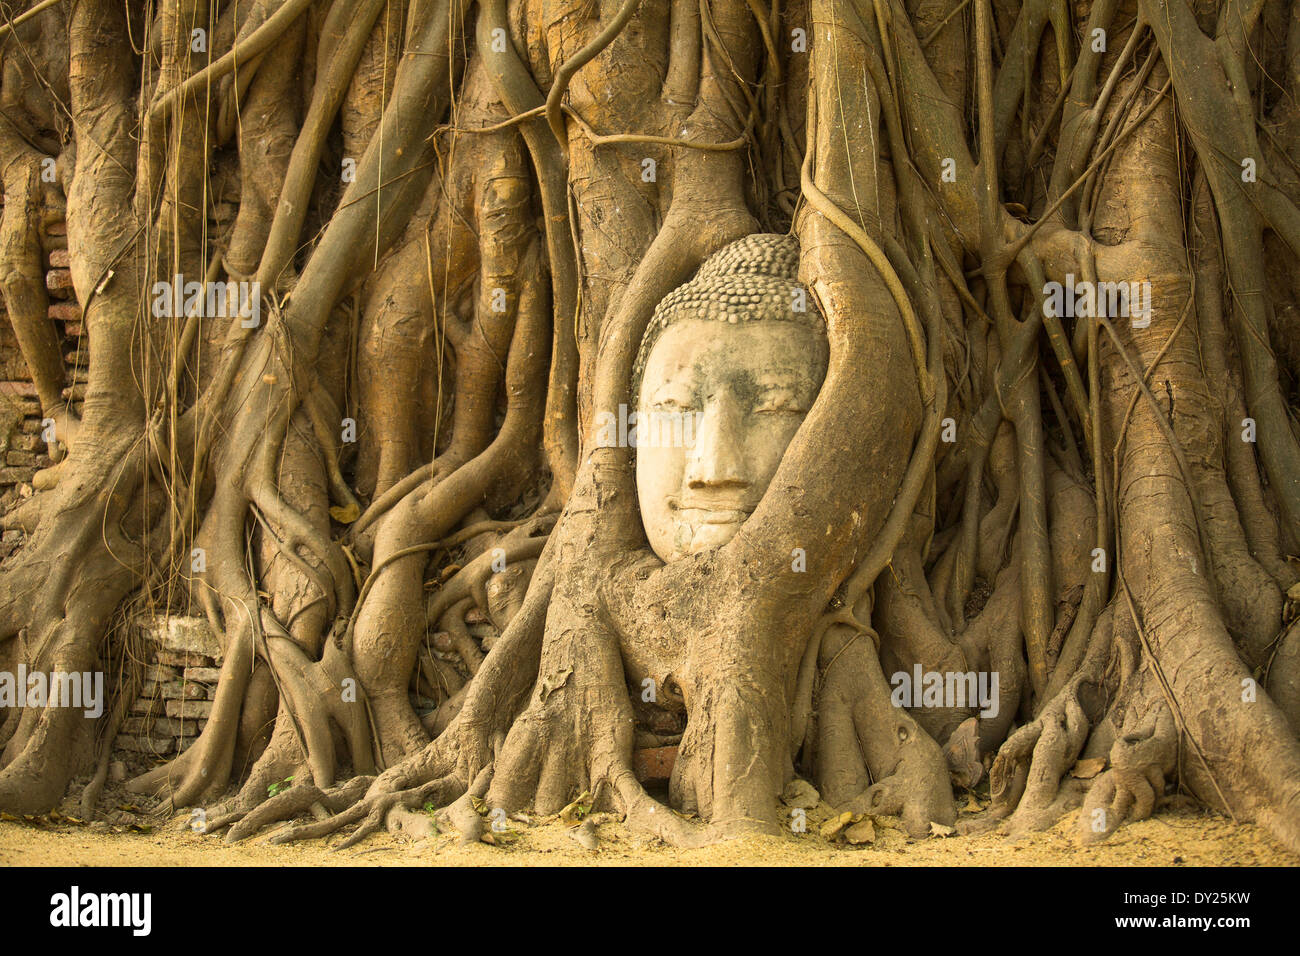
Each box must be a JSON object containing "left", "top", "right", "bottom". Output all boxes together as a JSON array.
[{"left": 637, "top": 319, "right": 828, "bottom": 562}]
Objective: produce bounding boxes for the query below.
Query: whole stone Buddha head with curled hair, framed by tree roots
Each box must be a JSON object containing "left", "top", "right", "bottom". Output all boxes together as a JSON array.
[{"left": 632, "top": 234, "right": 829, "bottom": 562}]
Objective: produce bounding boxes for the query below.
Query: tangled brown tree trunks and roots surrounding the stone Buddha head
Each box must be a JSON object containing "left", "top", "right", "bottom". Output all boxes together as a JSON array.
[{"left": 0, "top": 0, "right": 1300, "bottom": 851}]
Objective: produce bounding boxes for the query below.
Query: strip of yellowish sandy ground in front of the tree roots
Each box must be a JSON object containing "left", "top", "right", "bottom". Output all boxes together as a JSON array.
[{"left": 0, "top": 808, "right": 1300, "bottom": 866}]
